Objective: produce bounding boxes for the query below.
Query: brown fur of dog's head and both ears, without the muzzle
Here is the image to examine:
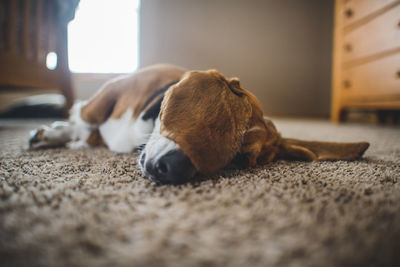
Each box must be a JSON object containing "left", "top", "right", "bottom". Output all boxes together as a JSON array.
[{"left": 160, "top": 70, "right": 369, "bottom": 173}]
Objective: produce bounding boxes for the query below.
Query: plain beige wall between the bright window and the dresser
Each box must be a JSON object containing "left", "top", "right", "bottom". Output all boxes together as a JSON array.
[{"left": 139, "top": 0, "right": 333, "bottom": 116}]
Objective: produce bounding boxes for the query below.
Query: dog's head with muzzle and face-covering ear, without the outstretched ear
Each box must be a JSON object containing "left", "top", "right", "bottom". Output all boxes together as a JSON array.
[{"left": 140, "top": 70, "right": 280, "bottom": 183}]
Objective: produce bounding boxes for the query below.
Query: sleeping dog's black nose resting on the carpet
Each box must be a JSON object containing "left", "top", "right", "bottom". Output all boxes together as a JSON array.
[{"left": 144, "top": 150, "right": 196, "bottom": 184}]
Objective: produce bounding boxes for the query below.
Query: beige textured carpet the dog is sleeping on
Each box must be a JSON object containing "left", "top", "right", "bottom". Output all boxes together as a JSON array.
[{"left": 0, "top": 120, "right": 400, "bottom": 266}]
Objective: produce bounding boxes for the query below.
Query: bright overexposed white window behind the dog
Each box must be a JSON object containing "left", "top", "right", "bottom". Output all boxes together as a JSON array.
[{"left": 68, "top": 0, "right": 140, "bottom": 73}]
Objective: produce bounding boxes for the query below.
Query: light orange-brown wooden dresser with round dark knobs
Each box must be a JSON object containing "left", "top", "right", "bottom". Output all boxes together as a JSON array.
[{"left": 331, "top": 0, "right": 400, "bottom": 122}]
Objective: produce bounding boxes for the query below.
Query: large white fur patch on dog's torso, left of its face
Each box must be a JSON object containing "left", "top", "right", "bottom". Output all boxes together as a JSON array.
[{"left": 99, "top": 109, "right": 154, "bottom": 153}]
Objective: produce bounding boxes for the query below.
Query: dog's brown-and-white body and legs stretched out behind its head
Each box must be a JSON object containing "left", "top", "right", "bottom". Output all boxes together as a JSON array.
[{"left": 30, "top": 65, "right": 185, "bottom": 153}]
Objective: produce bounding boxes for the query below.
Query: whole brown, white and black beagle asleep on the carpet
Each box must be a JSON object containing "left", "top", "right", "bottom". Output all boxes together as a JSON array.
[{"left": 29, "top": 65, "right": 369, "bottom": 184}]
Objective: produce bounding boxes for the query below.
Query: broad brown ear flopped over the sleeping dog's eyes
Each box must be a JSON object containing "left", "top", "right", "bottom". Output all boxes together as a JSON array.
[{"left": 160, "top": 70, "right": 252, "bottom": 173}]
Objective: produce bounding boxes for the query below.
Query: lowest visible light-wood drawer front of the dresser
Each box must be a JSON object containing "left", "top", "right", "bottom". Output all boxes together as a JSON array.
[{"left": 342, "top": 53, "right": 400, "bottom": 100}]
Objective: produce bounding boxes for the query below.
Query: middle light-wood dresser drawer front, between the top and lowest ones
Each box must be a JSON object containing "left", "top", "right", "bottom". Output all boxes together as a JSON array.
[{"left": 342, "top": 4, "right": 400, "bottom": 62}]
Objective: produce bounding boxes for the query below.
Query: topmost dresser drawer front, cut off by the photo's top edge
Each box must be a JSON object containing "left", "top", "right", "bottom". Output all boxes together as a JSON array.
[{"left": 342, "top": 0, "right": 396, "bottom": 26}]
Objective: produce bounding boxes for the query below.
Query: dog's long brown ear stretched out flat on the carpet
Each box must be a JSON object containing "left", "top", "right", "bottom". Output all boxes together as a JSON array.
[{"left": 278, "top": 138, "right": 369, "bottom": 160}]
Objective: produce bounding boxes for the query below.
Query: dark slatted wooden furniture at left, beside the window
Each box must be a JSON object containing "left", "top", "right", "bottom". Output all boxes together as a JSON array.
[{"left": 0, "top": 0, "right": 79, "bottom": 113}]
